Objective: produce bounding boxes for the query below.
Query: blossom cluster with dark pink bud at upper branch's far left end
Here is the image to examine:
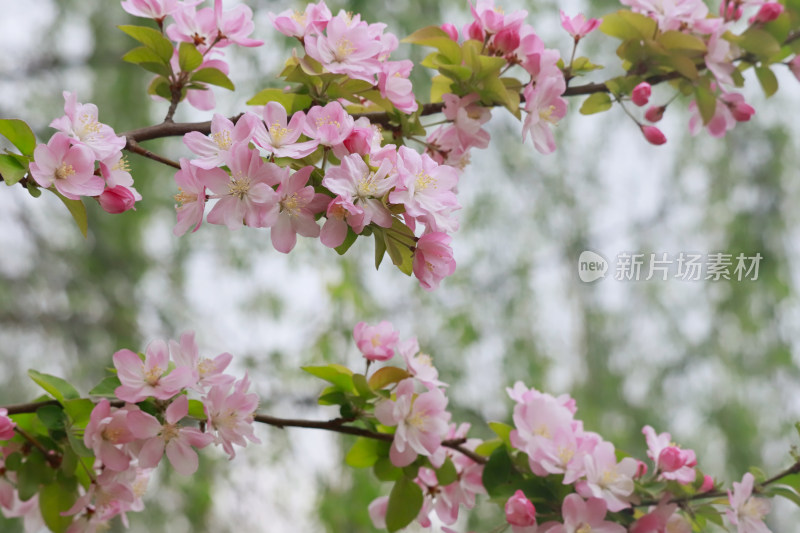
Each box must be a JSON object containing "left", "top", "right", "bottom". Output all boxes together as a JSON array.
[{"left": 30, "top": 91, "right": 142, "bottom": 214}]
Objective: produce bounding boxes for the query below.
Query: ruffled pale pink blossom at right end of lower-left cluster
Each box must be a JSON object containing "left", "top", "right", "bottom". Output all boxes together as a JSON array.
[{"left": 203, "top": 375, "right": 261, "bottom": 459}]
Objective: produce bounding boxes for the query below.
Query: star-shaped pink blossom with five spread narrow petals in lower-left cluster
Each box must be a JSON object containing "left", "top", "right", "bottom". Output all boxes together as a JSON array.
[{"left": 128, "top": 395, "right": 214, "bottom": 476}]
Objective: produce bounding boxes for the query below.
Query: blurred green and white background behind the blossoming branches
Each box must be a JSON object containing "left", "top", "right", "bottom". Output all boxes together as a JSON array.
[{"left": 0, "top": 0, "right": 800, "bottom": 533}]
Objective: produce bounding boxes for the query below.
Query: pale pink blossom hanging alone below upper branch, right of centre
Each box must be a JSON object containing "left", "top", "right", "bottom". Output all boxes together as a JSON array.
[{"left": 522, "top": 74, "right": 567, "bottom": 154}]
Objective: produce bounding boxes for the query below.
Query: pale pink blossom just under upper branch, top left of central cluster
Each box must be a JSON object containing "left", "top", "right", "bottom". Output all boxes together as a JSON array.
[{"left": 183, "top": 113, "right": 260, "bottom": 169}]
